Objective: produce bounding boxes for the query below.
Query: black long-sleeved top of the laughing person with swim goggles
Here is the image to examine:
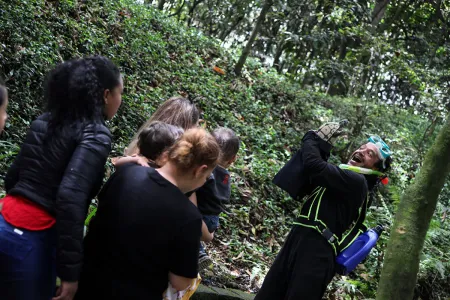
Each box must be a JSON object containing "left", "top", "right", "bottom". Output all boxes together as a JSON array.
[{"left": 274, "top": 131, "right": 369, "bottom": 238}]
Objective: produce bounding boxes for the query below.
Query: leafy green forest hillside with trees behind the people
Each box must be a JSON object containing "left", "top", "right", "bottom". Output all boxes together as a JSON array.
[{"left": 0, "top": 0, "right": 450, "bottom": 299}]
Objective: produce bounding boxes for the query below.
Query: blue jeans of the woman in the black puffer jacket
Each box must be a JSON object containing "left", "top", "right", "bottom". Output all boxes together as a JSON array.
[{"left": 0, "top": 214, "right": 56, "bottom": 300}]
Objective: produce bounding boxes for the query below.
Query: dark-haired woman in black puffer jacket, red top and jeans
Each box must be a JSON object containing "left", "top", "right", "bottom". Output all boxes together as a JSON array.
[{"left": 0, "top": 56, "right": 123, "bottom": 300}]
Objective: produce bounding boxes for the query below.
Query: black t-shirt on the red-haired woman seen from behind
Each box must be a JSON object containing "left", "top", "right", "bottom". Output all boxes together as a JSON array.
[{"left": 79, "top": 164, "right": 201, "bottom": 299}]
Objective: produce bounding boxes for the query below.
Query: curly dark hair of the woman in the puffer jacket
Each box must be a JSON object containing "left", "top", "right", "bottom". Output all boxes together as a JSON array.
[{"left": 44, "top": 56, "right": 120, "bottom": 129}]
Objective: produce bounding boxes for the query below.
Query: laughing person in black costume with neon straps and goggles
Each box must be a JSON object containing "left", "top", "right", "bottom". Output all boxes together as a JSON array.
[{"left": 255, "top": 123, "right": 391, "bottom": 300}]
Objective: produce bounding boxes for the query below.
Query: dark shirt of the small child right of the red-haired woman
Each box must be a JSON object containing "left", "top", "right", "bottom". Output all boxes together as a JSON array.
[{"left": 195, "top": 166, "right": 231, "bottom": 215}]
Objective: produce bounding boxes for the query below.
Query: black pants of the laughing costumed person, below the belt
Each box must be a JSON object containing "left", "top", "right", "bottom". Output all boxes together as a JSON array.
[{"left": 255, "top": 226, "right": 335, "bottom": 300}]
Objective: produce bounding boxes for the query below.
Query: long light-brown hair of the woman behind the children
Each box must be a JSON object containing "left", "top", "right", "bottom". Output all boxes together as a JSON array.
[{"left": 125, "top": 97, "right": 200, "bottom": 155}]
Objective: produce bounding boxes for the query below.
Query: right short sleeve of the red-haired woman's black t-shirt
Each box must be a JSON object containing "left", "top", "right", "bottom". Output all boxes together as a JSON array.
[{"left": 169, "top": 218, "right": 202, "bottom": 278}]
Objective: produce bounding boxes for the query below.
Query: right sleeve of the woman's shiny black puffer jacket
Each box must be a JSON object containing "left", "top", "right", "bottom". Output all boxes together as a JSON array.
[{"left": 56, "top": 126, "right": 111, "bottom": 281}]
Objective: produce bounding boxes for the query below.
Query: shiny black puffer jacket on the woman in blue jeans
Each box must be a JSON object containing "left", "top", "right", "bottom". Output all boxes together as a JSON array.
[{"left": 5, "top": 114, "right": 111, "bottom": 281}]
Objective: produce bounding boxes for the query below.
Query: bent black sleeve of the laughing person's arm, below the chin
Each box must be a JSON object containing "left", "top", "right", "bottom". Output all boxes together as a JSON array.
[{"left": 302, "top": 132, "right": 364, "bottom": 192}]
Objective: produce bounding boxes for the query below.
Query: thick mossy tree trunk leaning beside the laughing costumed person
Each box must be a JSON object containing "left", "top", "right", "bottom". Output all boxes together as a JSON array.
[{"left": 377, "top": 116, "right": 450, "bottom": 300}]
